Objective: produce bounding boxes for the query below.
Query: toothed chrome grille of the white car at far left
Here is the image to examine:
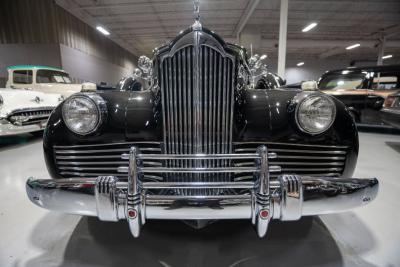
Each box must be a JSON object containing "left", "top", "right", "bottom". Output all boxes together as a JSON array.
[{"left": 8, "top": 108, "right": 53, "bottom": 126}]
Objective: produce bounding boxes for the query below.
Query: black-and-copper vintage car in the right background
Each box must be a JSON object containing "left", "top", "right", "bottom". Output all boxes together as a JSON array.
[{"left": 318, "top": 65, "right": 400, "bottom": 124}]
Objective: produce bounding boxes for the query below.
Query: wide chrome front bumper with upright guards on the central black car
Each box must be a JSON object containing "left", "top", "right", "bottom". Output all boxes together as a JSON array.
[{"left": 26, "top": 146, "right": 378, "bottom": 237}]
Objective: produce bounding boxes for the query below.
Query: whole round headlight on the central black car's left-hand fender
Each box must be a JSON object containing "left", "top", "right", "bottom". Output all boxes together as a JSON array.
[{"left": 62, "top": 94, "right": 106, "bottom": 135}]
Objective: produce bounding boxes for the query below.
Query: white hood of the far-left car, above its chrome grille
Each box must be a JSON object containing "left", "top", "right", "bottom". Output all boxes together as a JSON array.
[{"left": 0, "top": 88, "right": 62, "bottom": 117}]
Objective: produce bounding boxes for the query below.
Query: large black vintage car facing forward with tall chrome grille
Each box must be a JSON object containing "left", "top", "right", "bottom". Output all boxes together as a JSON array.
[{"left": 26, "top": 21, "right": 378, "bottom": 237}]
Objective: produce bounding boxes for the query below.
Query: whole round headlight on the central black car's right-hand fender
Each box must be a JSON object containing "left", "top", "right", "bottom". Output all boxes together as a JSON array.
[{"left": 296, "top": 95, "right": 336, "bottom": 134}]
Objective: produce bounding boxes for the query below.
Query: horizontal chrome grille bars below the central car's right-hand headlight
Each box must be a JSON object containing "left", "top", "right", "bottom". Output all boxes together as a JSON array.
[{"left": 234, "top": 142, "right": 349, "bottom": 181}]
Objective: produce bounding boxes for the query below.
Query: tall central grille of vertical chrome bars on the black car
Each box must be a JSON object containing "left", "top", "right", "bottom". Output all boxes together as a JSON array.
[{"left": 159, "top": 32, "right": 235, "bottom": 194}]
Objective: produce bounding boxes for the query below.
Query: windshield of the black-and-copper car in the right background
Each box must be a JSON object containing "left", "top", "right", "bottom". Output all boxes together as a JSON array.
[{"left": 318, "top": 73, "right": 365, "bottom": 90}]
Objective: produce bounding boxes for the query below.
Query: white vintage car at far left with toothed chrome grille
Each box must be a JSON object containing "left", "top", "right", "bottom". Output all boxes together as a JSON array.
[{"left": 0, "top": 88, "right": 64, "bottom": 136}]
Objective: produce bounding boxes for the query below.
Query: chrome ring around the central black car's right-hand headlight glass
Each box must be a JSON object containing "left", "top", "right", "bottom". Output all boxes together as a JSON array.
[{"left": 295, "top": 94, "right": 337, "bottom": 135}]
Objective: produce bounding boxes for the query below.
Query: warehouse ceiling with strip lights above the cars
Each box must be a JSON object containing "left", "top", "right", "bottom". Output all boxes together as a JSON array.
[{"left": 56, "top": 0, "right": 400, "bottom": 62}]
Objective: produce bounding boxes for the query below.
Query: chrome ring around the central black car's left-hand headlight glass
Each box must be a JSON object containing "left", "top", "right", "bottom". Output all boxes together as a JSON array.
[{"left": 61, "top": 93, "right": 107, "bottom": 136}]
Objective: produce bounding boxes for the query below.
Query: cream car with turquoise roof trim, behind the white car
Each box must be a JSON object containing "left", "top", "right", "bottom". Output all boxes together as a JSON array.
[{"left": 6, "top": 65, "right": 96, "bottom": 98}]
